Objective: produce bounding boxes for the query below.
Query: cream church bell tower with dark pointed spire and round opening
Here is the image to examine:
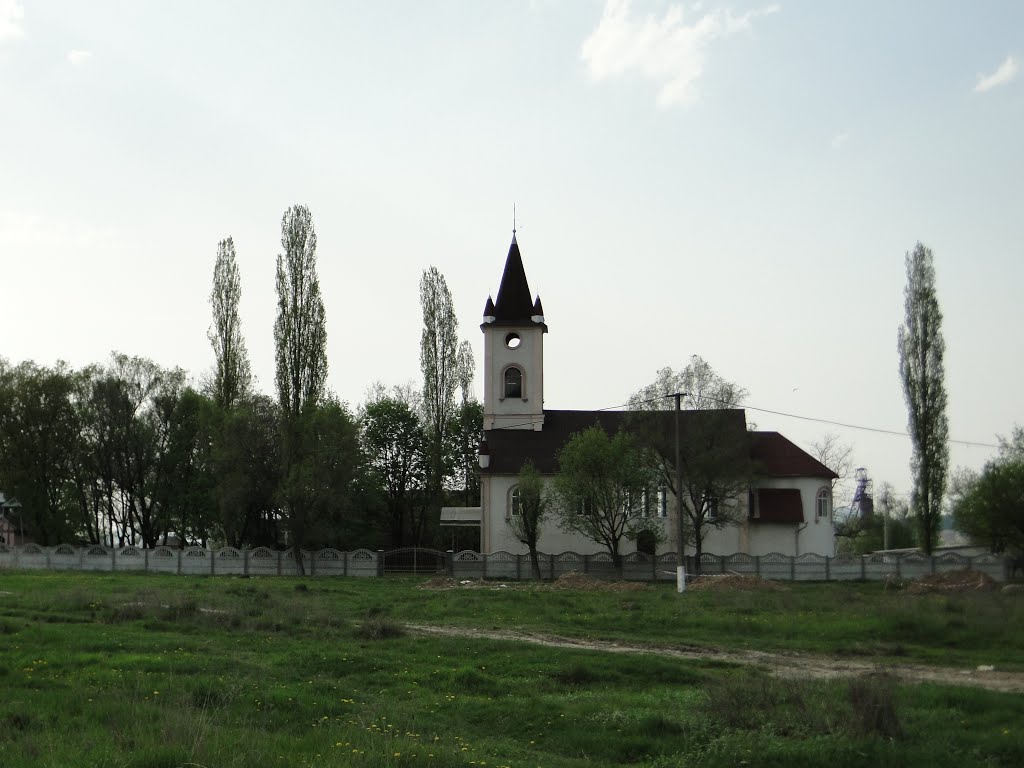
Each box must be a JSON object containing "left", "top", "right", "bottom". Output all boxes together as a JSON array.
[{"left": 480, "top": 229, "right": 548, "bottom": 431}]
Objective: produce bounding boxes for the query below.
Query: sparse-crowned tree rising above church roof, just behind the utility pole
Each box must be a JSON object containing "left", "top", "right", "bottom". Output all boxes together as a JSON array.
[{"left": 630, "top": 354, "right": 754, "bottom": 572}]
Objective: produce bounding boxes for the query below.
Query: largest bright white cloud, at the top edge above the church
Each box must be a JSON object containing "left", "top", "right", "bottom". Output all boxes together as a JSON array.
[{"left": 580, "top": 0, "right": 779, "bottom": 106}]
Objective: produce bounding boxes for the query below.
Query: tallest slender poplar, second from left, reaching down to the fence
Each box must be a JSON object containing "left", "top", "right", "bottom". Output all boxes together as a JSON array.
[{"left": 273, "top": 205, "right": 328, "bottom": 572}]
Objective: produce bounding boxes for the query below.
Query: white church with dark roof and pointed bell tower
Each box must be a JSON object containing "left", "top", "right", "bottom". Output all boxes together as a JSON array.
[{"left": 441, "top": 231, "right": 837, "bottom": 556}]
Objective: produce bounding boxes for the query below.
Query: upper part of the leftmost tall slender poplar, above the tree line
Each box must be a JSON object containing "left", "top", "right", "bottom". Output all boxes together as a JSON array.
[{"left": 208, "top": 238, "right": 249, "bottom": 411}]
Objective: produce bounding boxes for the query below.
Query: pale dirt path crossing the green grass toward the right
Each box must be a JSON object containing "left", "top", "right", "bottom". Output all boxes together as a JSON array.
[{"left": 406, "top": 624, "right": 1024, "bottom": 693}]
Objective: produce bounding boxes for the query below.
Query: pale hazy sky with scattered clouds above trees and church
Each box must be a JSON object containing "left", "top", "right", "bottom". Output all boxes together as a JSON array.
[{"left": 0, "top": 0, "right": 1024, "bottom": 505}]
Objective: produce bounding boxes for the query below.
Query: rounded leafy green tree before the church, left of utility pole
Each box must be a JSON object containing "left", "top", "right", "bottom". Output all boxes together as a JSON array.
[{"left": 554, "top": 425, "right": 662, "bottom": 575}]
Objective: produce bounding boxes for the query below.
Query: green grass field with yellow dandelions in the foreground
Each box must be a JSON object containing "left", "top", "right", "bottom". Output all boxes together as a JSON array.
[{"left": 0, "top": 572, "right": 1024, "bottom": 768}]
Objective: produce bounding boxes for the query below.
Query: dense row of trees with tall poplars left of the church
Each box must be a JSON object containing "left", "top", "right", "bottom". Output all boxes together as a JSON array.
[{"left": 0, "top": 205, "right": 483, "bottom": 549}]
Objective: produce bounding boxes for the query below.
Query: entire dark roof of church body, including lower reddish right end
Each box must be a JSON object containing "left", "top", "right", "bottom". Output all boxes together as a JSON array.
[{"left": 483, "top": 409, "right": 836, "bottom": 479}]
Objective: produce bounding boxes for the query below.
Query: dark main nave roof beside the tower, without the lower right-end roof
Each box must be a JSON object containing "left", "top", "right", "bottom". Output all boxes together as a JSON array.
[{"left": 483, "top": 409, "right": 746, "bottom": 474}]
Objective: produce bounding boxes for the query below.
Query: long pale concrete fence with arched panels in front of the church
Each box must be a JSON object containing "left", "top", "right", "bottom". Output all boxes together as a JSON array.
[{"left": 0, "top": 544, "right": 1011, "bottom": 582}]
